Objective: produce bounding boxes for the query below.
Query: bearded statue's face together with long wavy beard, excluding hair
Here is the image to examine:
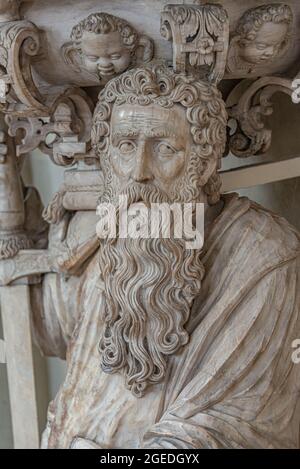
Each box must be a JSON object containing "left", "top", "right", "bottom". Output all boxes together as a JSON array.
[{"left": 100, "top": 104, "right": 204, "bottom": 397}]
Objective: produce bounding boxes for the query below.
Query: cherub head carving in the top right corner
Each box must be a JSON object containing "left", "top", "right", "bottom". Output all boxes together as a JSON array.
[{"left": 229, "top": 3, "right": 293, "bottom": 71}]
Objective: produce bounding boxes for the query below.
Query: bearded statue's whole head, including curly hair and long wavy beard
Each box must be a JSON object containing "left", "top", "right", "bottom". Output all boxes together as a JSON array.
[{"left": 92, "top": 64, "right": 227, "bottom": 397}]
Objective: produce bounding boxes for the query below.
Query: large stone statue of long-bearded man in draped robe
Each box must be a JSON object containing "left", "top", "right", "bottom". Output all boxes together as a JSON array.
[{"left": 31, "top": 63, "right": 300, "bottom": 449}]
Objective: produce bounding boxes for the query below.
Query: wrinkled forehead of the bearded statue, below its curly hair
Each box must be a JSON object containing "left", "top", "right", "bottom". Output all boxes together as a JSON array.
[{"left": 111, "top": 104, "right": 190, "bottom": 140}]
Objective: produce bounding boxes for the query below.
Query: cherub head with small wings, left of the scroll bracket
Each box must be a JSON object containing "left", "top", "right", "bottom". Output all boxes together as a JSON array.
[{"left": 63, "top": 13, "right": 153, "bottom": 83}]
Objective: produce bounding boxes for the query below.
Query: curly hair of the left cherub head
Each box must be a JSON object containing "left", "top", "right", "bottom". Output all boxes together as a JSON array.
[{"left": 71, "top": 13, "right": 138, "bottom": 51}]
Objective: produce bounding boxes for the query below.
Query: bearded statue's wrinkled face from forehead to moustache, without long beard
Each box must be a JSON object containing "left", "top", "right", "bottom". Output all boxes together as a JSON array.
[{"left": 110, "top": 104, "right": 192, "bottom": 201}]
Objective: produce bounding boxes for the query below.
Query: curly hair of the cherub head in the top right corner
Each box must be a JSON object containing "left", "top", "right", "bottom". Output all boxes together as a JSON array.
[{"left": 236, "top": 3, "right": 293, "bottom": 42}]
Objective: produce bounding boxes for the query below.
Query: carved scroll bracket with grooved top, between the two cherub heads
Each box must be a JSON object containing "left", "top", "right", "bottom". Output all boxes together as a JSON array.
[{"left": 161, "top": 4, "right": 229, "bottom": 83}]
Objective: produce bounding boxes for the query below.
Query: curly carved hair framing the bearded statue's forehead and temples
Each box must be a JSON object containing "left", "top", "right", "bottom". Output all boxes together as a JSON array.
[{"left": 92, "top": 63, "right": 227, "bottom": 204}]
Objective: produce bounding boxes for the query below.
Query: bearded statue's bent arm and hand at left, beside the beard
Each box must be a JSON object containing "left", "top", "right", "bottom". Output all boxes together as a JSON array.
[{"left": 32, "top": 208, "right": 99, "bottom": 359}]
